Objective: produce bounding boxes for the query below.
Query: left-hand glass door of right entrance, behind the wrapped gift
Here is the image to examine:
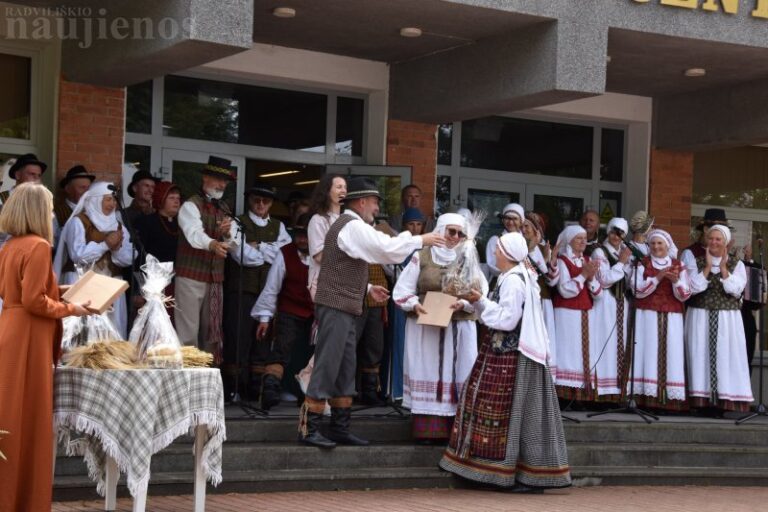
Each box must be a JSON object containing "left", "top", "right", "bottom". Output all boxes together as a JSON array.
[{"left": 459, "top": 177, "right": 525, "bottom": 263}]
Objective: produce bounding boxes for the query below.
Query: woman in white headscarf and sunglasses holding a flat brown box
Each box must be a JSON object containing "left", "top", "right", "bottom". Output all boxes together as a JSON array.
[{"left": 392, "top": 213, "right": 488, "bottom": 442}]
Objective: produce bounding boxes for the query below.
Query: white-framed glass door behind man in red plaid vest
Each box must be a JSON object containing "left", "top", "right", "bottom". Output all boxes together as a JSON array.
[{"left": 161, "top": 149, "right": 245, "bottom": 213}]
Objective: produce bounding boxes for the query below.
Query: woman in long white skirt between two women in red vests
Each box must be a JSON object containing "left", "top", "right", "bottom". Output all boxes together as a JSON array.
[{"left": 592, "top": 217, "right": 632, "bottom": 401}]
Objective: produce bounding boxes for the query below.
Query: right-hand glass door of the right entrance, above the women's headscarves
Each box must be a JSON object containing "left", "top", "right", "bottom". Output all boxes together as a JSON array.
[{"left": 525, "top": 185, "right": 592, "bottom": 245}]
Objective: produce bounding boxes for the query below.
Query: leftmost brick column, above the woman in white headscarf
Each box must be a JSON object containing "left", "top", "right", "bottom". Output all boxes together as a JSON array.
[{"left": 56, "top": 78, "right": 125, "bottom": 183}]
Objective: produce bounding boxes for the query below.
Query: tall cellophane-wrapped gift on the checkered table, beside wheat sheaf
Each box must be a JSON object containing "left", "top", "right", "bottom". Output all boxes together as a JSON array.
[{"left": 128, "top": 254, "right": 183, "bottom": 369}]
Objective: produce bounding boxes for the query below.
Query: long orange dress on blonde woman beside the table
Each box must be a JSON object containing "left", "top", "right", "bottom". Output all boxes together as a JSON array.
[{"left": 0, "top": 235, "right": 73, "bottom": 512}]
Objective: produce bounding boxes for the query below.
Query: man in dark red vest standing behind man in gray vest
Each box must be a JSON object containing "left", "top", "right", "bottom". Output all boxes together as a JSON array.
[{"left": 251, "top": 213, "right": 315, "bottom": 409}]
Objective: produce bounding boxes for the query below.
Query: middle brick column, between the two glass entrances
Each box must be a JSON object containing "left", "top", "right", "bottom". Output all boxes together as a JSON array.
[{"left": 387, "top": 119, "right": 437, "bottom": 217}]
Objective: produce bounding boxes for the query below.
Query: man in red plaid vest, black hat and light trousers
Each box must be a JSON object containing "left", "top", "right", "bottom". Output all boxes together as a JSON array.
[{"left": 175, "top": 156, "right": 236, "bottom": 364}]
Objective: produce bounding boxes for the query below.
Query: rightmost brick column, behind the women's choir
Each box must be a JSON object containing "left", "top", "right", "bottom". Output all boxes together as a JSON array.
[{"left": 648, "top": 149, "right": 693, "bottom": 247}]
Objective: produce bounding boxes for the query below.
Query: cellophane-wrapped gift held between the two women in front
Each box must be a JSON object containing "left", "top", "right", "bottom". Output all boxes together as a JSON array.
[{"left": 443, "top": 210, "right": 486, "bottom": 298}]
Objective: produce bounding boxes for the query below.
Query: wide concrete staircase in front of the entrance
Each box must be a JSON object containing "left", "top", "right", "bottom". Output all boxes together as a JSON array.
[{"left": 54, "top": 409, "right": 768, "bottom": 500}]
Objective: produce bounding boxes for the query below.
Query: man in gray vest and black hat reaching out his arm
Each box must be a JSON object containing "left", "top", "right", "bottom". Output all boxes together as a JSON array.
[{"left": 299, "top": 177, "right": 445, "bottom": 448}]
